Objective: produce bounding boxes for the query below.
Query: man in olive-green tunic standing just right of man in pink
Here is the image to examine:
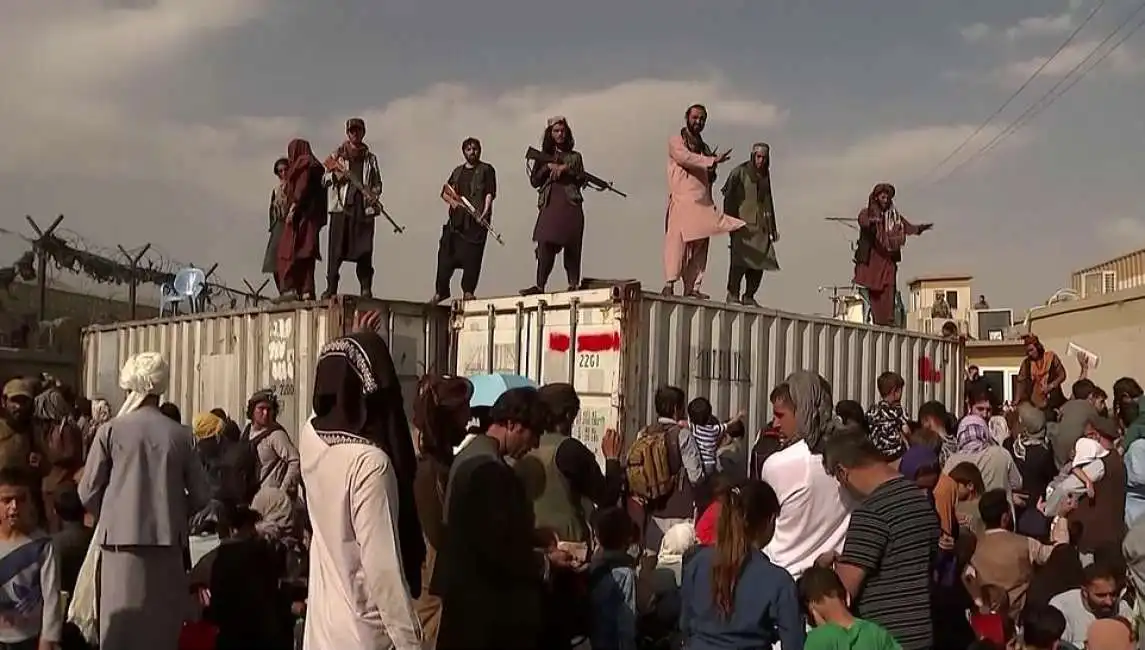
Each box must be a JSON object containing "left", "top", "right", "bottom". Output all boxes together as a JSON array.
[{"left": 722, "top": 142, "right": 780, "bottom": 307}]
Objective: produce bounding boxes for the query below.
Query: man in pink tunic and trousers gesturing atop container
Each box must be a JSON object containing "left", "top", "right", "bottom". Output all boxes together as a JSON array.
[{"left": 661, "top": 104, "right": 744, "bottom": 300}]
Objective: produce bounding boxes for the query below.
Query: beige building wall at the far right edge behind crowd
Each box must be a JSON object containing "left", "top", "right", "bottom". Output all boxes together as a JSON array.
[{"left": 1029, "top": 286, "right": 1145, "bottom": 390}]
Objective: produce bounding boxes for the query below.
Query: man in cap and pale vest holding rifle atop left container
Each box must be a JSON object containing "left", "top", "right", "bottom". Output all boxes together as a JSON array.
[{"left": 322, "top": 118, "right": 381, "bottom": 299}]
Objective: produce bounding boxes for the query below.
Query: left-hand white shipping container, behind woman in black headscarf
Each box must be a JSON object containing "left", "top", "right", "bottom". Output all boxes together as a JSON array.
[{"left": 77, "top": 296, "right": 451, "bottom": 436}]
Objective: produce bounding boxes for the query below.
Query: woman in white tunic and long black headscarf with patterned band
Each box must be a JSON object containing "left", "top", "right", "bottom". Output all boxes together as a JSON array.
[{"left": 299, "top": 314, "right": 426, "bottom": 650}]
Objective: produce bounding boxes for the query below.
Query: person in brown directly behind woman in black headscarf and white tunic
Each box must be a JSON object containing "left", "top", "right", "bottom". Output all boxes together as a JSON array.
[{"left": 413, "top": 374, "right": 473, "bottom": 649}]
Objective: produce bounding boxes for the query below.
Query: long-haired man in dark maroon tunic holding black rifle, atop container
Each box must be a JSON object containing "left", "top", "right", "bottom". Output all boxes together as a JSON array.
[{"left": 521, "top": 116, "right": 585, "bottom": 295}]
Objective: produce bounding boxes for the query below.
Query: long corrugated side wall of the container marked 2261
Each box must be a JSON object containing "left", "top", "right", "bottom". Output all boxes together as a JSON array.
[{"left": 625, "top": 293, "right": 963, "bottom": 430}]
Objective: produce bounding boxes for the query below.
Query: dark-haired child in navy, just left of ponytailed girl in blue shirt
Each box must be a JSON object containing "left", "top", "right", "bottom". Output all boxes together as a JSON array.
[{"left": 589, "top": 507, "right": 637, "bottom": 650}]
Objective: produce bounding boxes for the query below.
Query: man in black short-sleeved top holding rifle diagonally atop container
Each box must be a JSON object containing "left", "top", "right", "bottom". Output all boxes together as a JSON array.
[{"left": 432, "top": 137, "right": 497, "bottom": 303}]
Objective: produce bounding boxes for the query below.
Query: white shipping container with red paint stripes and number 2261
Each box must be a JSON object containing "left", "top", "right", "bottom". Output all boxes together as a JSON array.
[{"left": 453, "top": 283, "right": 963, "bottom": 457}]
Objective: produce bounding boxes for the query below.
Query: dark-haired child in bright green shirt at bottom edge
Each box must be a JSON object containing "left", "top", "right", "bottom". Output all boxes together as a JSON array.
[{"left": 798, "top": 566, "right": 901, "bottom": 650}]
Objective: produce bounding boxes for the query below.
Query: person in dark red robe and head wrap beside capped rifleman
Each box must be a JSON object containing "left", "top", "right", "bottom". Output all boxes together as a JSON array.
[{"left": 275, "top": 138, "right": 326, "bottom": 301}]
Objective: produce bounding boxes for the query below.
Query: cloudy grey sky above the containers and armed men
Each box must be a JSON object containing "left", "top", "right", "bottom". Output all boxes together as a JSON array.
[{"left": 0, "top": 0, "right": 1145, "bottom": 311}]
